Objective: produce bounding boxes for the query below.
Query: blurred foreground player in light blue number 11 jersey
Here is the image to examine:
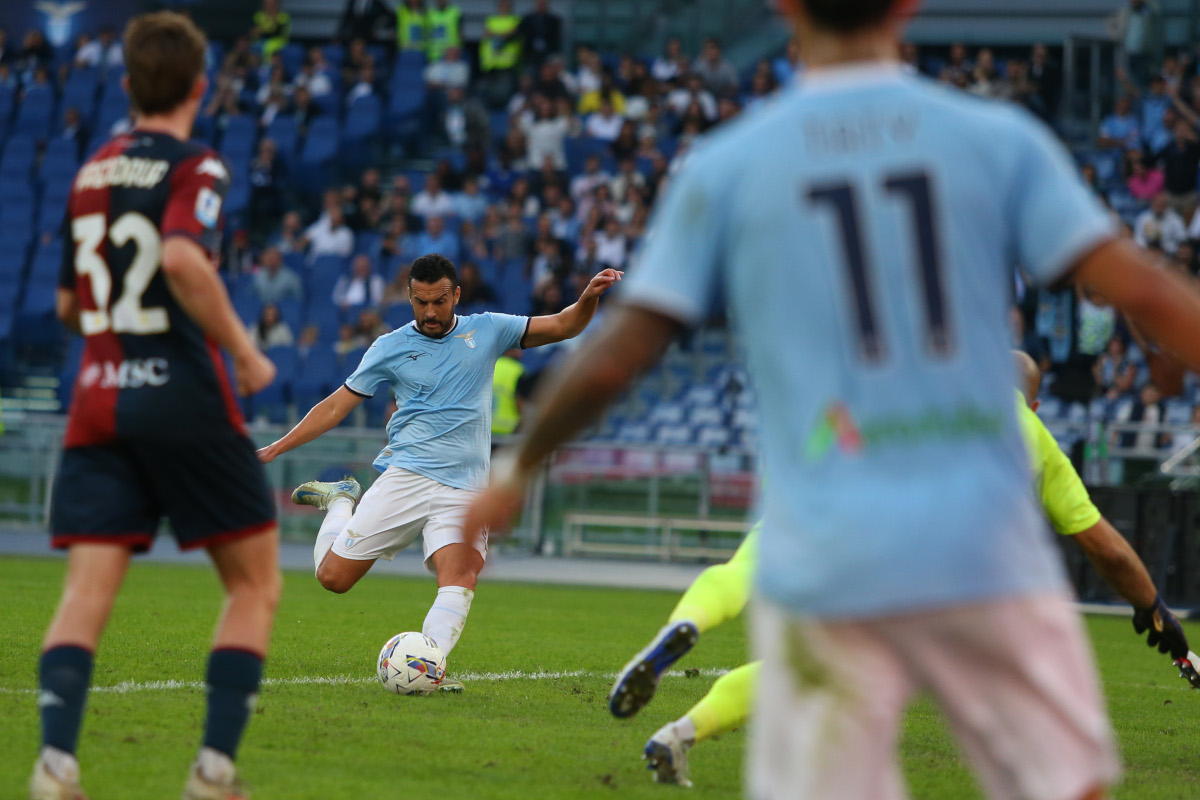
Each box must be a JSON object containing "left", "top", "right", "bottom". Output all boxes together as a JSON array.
[{"left": 466, "top": 0, "right": 1200, "bottom": 800}]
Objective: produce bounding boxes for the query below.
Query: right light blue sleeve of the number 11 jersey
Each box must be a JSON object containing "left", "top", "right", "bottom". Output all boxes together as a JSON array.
[{"left": 1007, "top": 115, "right": 1115, "bottom": 285}]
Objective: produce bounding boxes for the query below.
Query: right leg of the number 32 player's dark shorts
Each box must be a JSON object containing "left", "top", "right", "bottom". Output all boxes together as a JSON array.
[{"left": 137, "top": 431, "right": 275, "bottom": 551}]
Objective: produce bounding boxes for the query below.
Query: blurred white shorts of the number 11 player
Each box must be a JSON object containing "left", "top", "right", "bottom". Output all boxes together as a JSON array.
[{"left": 746, "top": 595, "right": 1121, "bottom": 800}]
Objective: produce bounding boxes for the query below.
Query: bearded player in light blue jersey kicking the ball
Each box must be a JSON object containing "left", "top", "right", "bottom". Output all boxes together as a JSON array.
[{"left": 259, "top": 254, "right": 622, "bottom": 688}]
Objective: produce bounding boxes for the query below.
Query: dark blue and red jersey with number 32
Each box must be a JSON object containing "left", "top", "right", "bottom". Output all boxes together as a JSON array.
[{"left": 59, "top": 130, "right": 245, "bottom": 447}]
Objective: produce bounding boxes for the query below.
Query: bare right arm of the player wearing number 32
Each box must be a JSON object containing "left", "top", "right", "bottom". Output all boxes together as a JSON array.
[{"left": 162, "top": 236, "right": 275, "bottom": 395}]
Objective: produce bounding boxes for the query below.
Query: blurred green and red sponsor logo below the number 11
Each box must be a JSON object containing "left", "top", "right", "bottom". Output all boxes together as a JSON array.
[{"left": 804, "top": 401, "right": 1003, "bottom": 462}]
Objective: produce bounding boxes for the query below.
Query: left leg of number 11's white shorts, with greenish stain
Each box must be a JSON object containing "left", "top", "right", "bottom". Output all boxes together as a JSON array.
[{"left": 746, "top": 600, "right": 912, "bottom": 800}]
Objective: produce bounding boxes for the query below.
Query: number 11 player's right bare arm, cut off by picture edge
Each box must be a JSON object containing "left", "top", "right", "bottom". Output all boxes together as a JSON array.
[{"left": 1075, "top": 240, "right": 1200, "bottom": 372}]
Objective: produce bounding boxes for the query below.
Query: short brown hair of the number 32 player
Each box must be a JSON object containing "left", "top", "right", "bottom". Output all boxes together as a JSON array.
[{"left": 124, "top": 11, "right": 208, "bottom": 115}]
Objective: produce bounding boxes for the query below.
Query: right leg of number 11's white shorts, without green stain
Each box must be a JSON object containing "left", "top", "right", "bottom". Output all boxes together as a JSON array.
[{"left": 892, "top": 595, "right": 1120, "bottom": 800}]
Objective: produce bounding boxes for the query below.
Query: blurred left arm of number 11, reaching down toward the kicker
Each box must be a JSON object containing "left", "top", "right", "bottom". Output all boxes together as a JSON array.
[{"left": 463, "top": 307, "right": 680, "bottom": 537}]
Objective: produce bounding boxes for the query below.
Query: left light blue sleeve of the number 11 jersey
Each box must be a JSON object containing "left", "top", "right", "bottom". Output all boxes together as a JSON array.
[{"left": 622, "top": 154, "right": 725, "bottom": 326}]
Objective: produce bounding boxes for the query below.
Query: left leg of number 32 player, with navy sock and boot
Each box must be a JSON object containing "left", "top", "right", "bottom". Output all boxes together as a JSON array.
[{"left": 30, "top": 542, "right": 131, "bottom": 800}]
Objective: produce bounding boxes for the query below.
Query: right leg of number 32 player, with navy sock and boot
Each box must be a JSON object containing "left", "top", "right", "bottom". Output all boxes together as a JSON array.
[{"left": 184, "top": 528, "right": 282, "bottom": 800}]
